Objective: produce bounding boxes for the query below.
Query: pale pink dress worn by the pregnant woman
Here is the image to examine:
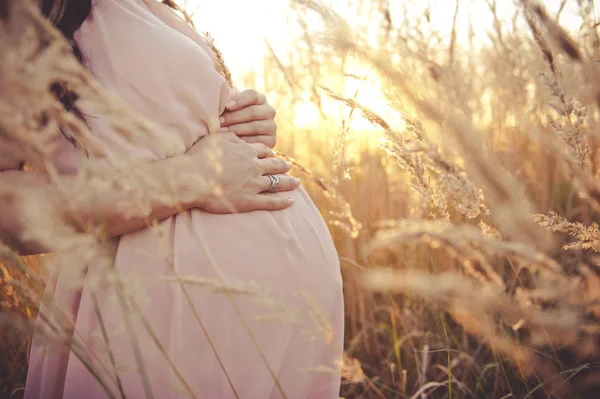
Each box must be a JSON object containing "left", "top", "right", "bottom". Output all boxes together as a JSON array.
[{"left": 25, "top": 0, "right": 344, "bottom": 399}]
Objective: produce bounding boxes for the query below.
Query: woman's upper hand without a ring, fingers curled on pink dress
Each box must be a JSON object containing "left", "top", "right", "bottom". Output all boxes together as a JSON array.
[{"left": 220, "top": 90, "right": 277, "bottom": 148}]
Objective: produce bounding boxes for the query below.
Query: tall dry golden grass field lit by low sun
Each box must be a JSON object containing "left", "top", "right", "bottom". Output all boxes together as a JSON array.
[{"left": 0, "top": 0, "right": 600, "bottom": 399}]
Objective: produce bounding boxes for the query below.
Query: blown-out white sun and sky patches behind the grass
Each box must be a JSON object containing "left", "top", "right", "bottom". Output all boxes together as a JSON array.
[{"left": 184, "top": 0, "right": 596, "bottom": 132}]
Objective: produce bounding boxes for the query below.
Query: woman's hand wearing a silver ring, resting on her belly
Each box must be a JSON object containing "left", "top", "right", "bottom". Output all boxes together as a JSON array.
[{"left": 185, "top": 133, "right": 300, "bottom": 213}]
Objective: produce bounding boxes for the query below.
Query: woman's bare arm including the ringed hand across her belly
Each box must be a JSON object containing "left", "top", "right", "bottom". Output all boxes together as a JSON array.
[{"left": 0, "top": 133, "right": 300, "bottom": 254}]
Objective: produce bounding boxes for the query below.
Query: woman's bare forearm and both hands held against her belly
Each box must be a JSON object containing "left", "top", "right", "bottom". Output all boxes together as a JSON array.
[{"left": 0, "top": 90, "right": 300, "bottom": 254}]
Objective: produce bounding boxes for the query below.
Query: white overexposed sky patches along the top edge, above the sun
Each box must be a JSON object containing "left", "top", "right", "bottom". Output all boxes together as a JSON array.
[{"left": 191, "top": 0, "right": 598, "bottom": 73}]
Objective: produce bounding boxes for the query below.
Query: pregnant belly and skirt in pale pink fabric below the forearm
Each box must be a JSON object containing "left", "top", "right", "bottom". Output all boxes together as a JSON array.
[{"left": 54, "top": 189, "right": 344, "bottom": 399}]
